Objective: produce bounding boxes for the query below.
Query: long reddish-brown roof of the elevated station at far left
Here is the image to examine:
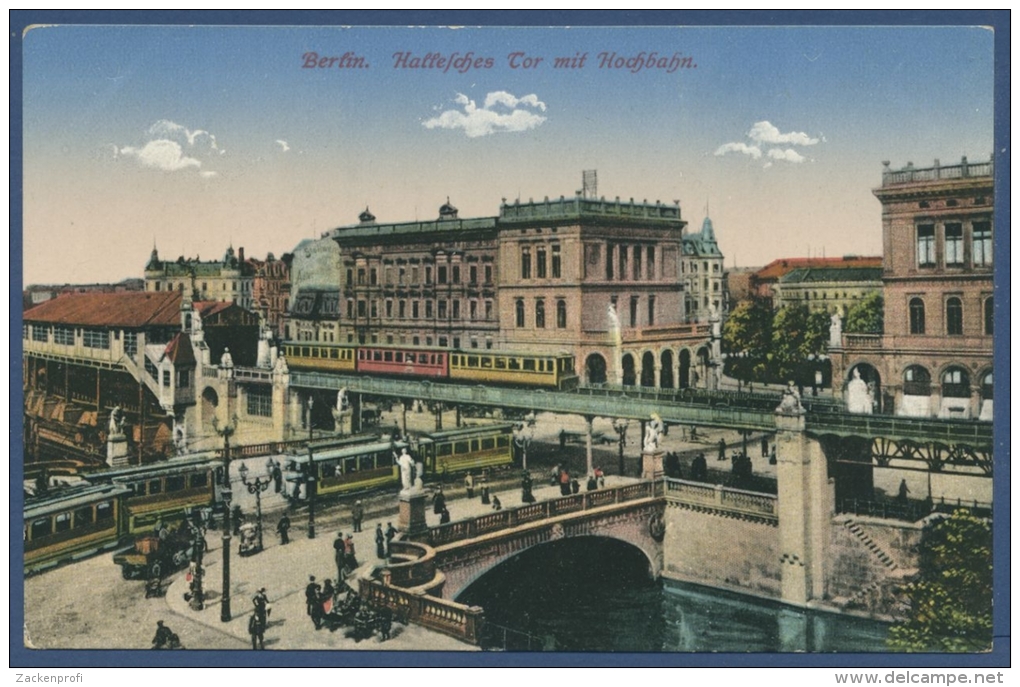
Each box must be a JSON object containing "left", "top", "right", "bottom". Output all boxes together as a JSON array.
[{"left": 23, "top": 292, "right": 181, "bottom": 329}]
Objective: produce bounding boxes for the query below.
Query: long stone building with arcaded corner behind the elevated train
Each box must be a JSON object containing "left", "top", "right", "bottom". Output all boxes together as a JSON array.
[{"left": 297, "top": 188, "right": 722, "bottom": 387}]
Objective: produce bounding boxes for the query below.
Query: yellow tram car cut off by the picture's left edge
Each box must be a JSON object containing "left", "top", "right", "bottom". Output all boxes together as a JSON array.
[{"left": 23, "top": 484, "right": 129, "bottom": 574}]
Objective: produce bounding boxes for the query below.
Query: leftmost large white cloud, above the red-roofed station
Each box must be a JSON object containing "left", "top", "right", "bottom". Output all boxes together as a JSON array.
[{"left": 113, "top": 119, "right": 226, "bottom": 178}]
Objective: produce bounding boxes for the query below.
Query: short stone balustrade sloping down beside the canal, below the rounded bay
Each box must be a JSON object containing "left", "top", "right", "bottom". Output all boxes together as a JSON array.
[{"left": 358, "top": 578, "right": 485, "bottom": 644}]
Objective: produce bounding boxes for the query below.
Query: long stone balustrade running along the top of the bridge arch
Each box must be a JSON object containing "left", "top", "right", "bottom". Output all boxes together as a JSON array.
[{"left": 425, "top": 480, "right": 662, "bottom": 546}]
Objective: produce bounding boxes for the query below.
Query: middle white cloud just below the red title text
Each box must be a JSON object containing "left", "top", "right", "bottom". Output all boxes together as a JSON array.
[{"left": 422, "top": 91, "right": 546, "bottom": 139}]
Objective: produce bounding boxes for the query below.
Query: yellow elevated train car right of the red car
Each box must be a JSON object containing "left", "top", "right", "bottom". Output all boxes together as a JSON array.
[{"left": 450, "top": 351, "right": 577, "bottom": 390}]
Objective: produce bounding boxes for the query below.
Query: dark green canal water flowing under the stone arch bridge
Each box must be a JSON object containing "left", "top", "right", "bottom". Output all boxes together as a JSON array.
[{"left": 457, "top": 537, "right": 888, "bottom": 652}]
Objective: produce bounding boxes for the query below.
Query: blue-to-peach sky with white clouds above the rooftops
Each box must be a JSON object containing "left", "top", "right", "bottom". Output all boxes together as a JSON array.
[{"left": 22, "top": 21, "right": 993, "bottom": 284}]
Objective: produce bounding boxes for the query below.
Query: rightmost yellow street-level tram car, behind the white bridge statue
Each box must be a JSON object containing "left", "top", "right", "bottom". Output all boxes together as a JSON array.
[{"left": 417, "top": 422, "right": 513, "bottom": 477}]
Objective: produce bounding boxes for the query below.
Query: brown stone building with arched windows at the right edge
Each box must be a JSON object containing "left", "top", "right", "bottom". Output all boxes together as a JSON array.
[{"left": 832, "top": 158, "right": 995, "bottom": 420}]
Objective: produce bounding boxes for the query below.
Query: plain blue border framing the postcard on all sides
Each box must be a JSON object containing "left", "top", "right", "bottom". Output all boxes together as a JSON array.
[{"left": 9, "top": 10, "right": 1011, "bottom": 668}]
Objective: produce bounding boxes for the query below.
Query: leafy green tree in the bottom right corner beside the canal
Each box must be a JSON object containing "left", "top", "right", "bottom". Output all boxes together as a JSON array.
[{"left": 888, "top": 510, "right": 991, "bottom": 651}]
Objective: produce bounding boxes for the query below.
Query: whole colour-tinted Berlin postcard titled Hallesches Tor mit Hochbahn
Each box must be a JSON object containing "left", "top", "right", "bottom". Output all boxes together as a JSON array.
[{"left": 11, "top": 15, "right": 1009, "bottom": 666}]
